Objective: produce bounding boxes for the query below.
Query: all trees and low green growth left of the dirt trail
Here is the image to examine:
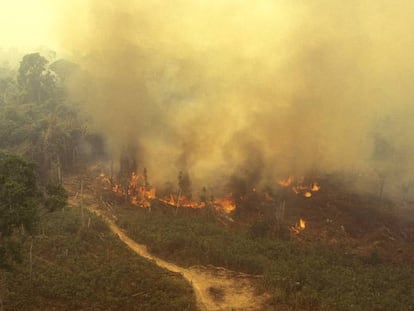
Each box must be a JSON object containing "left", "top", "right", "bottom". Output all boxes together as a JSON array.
[{"left": 0, "top": 53, "right": 196, "bottom": 310}]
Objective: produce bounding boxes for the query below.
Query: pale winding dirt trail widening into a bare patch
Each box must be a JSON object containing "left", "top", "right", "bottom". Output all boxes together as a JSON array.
[{"left": 69, "top": 195, "right": 267, "bottom": 311}]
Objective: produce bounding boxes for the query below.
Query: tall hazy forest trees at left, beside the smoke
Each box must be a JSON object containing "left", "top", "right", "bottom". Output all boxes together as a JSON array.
[{"left": 0, "top": 53, "right": 102, "bottom": 184}]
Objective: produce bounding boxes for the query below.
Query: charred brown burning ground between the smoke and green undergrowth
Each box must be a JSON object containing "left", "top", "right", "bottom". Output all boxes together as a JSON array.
[{"left": 90, "top": 163, "right": 414, "bottom": 263}]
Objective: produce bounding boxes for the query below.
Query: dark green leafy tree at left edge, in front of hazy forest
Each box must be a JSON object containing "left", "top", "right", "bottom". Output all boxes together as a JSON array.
[{"left": 0, "top": 152, "right": 40, "bottom": 267}]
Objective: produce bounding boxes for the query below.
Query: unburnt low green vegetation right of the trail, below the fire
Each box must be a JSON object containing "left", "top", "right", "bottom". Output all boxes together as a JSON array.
[{"left": 117, "top": 208, "right": 414, "bottom": 310}]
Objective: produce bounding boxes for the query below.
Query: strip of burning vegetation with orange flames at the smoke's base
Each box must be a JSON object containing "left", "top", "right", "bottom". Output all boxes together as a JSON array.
[{"left": 97, "top": 160, "right": 330, "bottom": 238}]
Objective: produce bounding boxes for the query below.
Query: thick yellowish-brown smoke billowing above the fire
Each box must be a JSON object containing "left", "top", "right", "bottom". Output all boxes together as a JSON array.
[{"left": 59, "top": 0, "right": 414, "bottom": 197}]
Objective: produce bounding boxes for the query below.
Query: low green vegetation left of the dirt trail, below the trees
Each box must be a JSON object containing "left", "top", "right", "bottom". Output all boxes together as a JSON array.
[{"left": 3, "top": 208, "right": 196, "bottom": 311}]
